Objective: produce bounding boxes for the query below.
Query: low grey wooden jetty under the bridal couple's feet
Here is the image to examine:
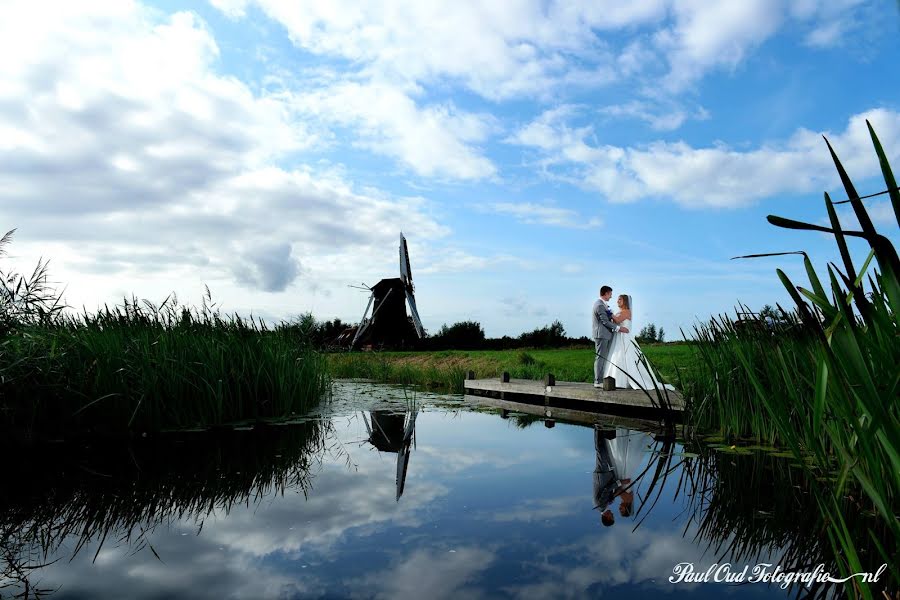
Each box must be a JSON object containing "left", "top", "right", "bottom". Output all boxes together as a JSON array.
[{"left": 464, "top": 372, "right": 684, "bottom": 417}]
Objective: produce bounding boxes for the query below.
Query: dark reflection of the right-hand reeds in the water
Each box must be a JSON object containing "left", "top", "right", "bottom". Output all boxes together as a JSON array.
[{"left": 679, "top": 445, "right": 900, "bottom": 598}]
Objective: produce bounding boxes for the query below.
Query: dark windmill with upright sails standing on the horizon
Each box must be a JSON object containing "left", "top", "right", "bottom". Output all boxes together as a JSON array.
[{"left": 350, "top": 232, "right": 425, "bottom": 348}]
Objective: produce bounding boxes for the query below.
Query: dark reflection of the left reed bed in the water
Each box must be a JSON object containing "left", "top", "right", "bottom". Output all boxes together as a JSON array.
[{"left": 0, "top": 420, "right": 330, "bottom": 598}]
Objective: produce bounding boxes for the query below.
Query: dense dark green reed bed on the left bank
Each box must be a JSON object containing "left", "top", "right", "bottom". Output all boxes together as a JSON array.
[{"left": 0, "top": 244, "right": 329, "bottom": 438}]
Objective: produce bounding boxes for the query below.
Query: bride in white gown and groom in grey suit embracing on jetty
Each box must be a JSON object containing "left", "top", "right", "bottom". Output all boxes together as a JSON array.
[{"left": 591, "top": 285, "right": 672, "bottom": 390}]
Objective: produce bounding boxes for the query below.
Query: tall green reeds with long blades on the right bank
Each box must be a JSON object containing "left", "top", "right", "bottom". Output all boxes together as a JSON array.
[{"left": 685, "top": 119, "right": 900, "bottom": 595}]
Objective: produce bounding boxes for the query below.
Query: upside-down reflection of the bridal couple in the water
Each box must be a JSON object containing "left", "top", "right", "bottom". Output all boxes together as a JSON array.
[{"left": 594, "top": 425, "right": 653, "bottom": 527}]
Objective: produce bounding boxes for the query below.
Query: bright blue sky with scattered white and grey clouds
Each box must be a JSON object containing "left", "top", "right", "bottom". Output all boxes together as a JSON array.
[{"left": 0, "top": 0, "right": 900, "bottom": 340}]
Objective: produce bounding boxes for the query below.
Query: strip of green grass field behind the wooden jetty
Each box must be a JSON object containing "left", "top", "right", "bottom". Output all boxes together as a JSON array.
[{"left": 328, "top": 344, "right": 696, "bottom": 392}]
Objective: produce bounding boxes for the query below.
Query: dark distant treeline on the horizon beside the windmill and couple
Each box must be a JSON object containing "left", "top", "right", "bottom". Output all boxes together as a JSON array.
[{"left": 291, "top": 314, "right": 665, "bottom": 350}]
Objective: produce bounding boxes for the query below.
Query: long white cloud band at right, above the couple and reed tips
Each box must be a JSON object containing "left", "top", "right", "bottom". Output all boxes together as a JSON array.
[{"left": 510, "top": 109, "right": 900, "bottom": 207}]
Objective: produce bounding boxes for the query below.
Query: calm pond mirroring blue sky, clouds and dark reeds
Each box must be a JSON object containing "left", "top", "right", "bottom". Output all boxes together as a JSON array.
[{"left": 0, "top": 382, "right": 880, "bottom": 598}]
